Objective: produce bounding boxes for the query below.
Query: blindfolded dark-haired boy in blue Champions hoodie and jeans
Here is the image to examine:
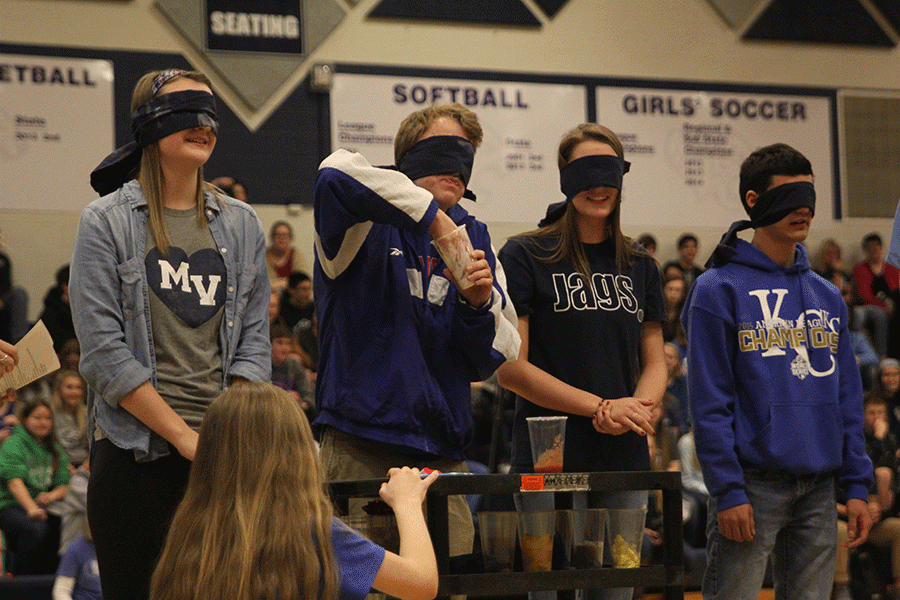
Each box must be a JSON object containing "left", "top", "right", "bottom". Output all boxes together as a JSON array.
[{"left": 682, "top": 144, "right": 872, "bottom": 600}]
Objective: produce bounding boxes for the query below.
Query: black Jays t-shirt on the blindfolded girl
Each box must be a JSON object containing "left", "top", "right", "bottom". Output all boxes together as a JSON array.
[{"left": 499, "top": 236, "right": 666, "bottom": 472}]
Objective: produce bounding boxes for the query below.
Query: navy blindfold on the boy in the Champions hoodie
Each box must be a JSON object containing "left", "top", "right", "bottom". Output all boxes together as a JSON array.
[{"left": 706, "top": 181, "right": 816, "bottom": 269}]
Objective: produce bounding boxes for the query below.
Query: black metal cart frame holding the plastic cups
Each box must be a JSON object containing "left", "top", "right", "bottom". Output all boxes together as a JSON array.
[{"left": 329, "top": 471, "right": 684, "bottom": 600}]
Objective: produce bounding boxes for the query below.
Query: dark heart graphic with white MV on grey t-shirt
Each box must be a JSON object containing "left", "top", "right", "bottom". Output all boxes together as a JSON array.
[{"left": 144, "top": 246, "right": 227, "bottom": 327}]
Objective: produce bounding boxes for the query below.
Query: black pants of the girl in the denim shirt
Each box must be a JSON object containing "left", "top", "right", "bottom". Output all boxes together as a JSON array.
[{"left": 87, "top": 439, "right": 191, "bottom": 600}]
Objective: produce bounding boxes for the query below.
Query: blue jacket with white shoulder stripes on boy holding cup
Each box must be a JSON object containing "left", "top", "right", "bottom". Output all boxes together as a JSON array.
[{"left": 313, "top": 150, "right": 520, "bottom": 460}]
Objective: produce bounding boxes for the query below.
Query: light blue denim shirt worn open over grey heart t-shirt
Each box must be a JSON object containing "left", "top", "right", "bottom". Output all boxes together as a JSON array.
[{"left": 69, "top": 181, "right": 272, "bottom": 462}]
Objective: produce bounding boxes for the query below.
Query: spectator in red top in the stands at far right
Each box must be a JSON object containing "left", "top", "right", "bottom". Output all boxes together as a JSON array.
[{"left": 853, "top": 233, "right": 900, "bottom": 358}]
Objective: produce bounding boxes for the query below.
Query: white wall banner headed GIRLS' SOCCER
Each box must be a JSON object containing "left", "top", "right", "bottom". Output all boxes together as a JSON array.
[{"left": 596, "top": 86, "right": 835, "bottom": 227}]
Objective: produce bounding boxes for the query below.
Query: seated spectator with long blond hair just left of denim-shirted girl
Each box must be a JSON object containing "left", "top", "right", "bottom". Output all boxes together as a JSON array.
[{"left": 50, "top": 371, "right": 88, "bottom": 473}]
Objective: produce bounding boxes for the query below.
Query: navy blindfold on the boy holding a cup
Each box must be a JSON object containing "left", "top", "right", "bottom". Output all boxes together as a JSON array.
[{"left": 397, "top": 135, "right": 475, "bottom": 200}]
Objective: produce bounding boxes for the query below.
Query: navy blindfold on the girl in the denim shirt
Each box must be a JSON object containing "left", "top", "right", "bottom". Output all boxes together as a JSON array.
[{"left": 91, "top": 90, "right": 219, "bottom": 196}]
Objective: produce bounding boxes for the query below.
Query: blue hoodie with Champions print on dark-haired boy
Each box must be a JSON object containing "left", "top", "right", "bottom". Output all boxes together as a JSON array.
[{"left": 682, "top": 240, "right": 872, "bottom": 510}]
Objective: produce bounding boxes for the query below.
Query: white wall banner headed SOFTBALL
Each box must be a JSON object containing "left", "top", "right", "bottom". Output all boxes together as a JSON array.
[{"left": 331, "top": 73, "right": 587, "bottom": 227}]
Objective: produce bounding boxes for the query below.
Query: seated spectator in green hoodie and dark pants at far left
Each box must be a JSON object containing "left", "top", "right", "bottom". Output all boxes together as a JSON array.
[{"left": 0, "top": 400, "right": 70, "bottom": 575}]
